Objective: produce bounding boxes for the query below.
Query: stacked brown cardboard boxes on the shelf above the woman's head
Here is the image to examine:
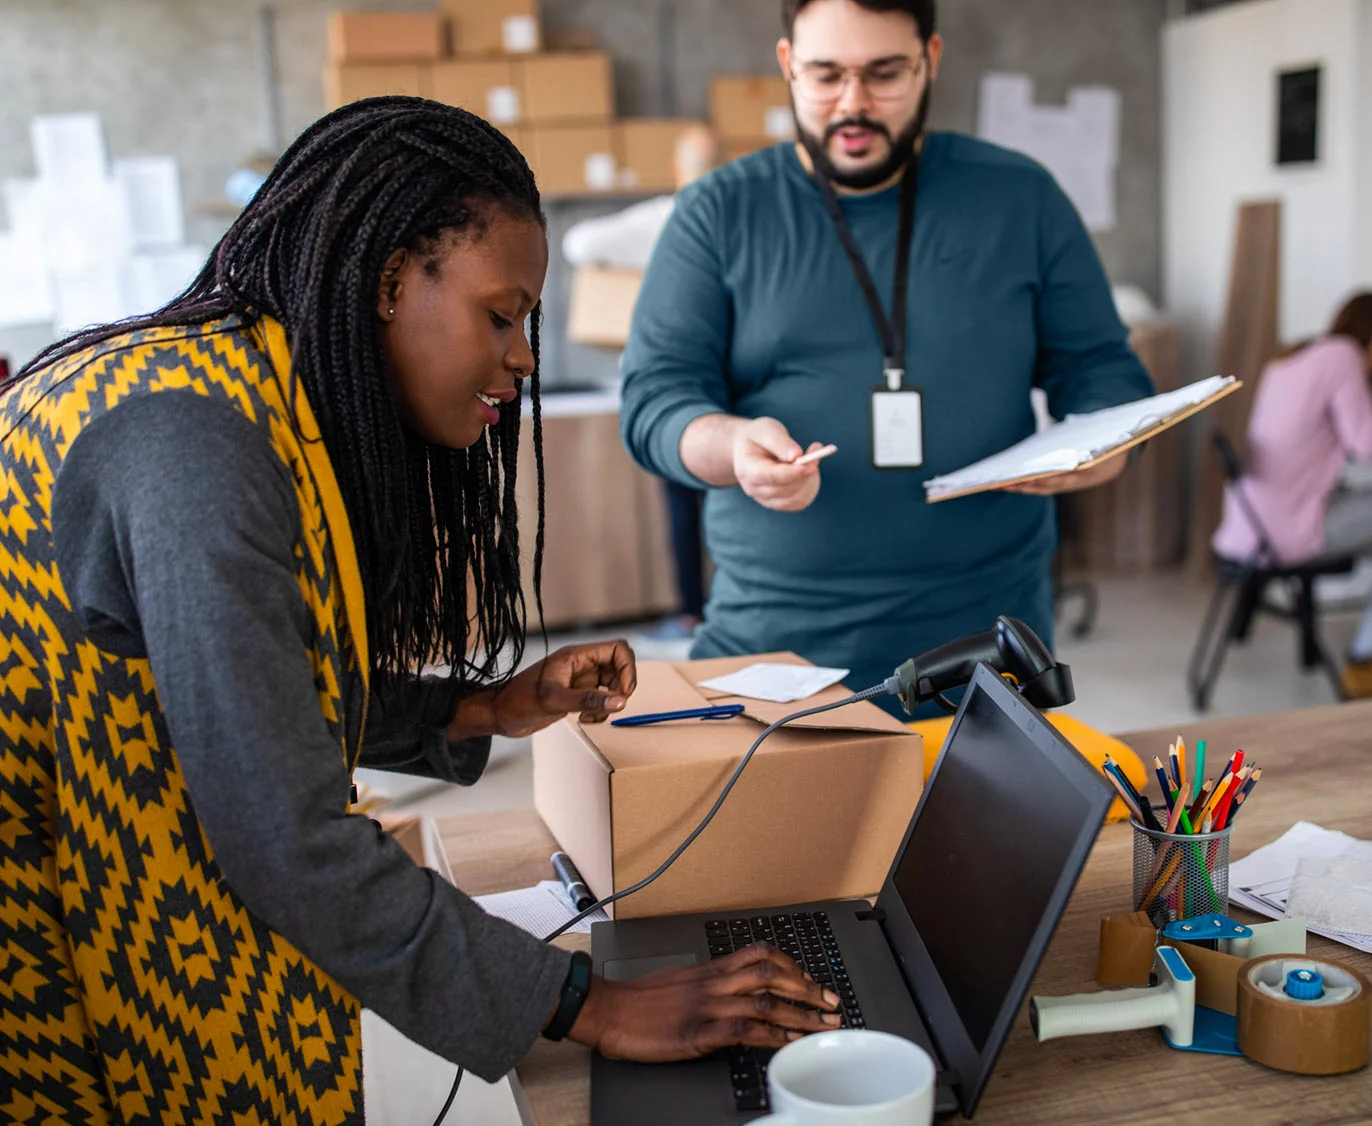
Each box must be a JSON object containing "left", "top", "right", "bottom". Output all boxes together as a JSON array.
[{"left": 325, "top": 0, "right": 693, "bottom": 196}]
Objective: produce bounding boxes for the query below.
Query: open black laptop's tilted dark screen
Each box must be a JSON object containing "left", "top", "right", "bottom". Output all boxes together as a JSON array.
[{"left": 882, "top": 668, "right": 1110, "bottom": 1114}]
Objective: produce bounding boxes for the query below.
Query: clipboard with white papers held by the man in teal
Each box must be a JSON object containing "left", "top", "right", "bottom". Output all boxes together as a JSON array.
[{"left": 925, "top": 376, "right": 1242, "bottom": 503}]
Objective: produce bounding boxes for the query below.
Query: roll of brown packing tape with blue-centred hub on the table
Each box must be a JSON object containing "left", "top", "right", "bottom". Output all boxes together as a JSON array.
[{"left": 1238, "top": 955, "right": 1372, "bottom": 1075}]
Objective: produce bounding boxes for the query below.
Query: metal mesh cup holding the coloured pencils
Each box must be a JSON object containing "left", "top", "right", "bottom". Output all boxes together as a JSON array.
[{"left": 1131, "top": 820, "right": 1231, "bottom": 927}]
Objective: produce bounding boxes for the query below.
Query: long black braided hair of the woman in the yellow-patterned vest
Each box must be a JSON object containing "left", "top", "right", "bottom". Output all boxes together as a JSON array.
[{"left": 14, "top": 97, "right": 546, "bottom": 687}]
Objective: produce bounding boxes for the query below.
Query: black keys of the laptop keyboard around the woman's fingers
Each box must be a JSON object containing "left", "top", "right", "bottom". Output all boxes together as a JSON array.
[{"left": 705, "top": 911, "right": 867, "bottom": 1111}]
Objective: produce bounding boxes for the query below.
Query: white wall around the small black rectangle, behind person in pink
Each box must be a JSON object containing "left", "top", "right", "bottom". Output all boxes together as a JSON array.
[{"left": 1163, "top": 0, "right": 1372, "bottom": 373}]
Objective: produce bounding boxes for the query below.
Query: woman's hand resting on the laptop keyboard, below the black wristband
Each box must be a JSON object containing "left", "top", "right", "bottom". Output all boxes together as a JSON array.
[{"left": 569, "top": 945, "right": 840, "bottom": 1063}]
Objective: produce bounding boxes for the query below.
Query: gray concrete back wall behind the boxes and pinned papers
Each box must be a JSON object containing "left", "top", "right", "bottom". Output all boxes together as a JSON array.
[{"left": 0, "top": 0, "right": 1170, "bottom": 381}]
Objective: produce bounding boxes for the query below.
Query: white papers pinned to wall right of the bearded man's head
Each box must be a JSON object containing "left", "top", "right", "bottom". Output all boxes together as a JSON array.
[{"left": 977, "top": 73, "right": 1120, "bottom": 230}]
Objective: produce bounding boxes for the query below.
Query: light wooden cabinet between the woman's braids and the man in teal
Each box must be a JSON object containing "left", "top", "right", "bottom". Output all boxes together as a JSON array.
[{"left": 517, "top": 396, "right": 676, "bottom": 630}]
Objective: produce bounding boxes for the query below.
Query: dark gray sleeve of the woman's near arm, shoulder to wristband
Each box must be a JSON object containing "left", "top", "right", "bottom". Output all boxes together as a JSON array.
[{"left": 52, "top": 392, "right": 569, "bottom": 1081}]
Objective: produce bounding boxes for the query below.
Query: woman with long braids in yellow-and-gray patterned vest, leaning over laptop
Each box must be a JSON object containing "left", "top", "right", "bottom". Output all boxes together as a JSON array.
[{"left": 0, "top": 99, "right": 833, "bottom": 1123}]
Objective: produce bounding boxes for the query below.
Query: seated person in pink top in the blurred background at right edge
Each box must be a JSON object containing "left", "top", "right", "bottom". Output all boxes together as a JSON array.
[{"left": 1210, "top": 294, "right": 1372, "bottom": 697}]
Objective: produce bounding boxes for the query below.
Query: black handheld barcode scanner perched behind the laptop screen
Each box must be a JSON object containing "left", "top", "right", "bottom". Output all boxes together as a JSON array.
[{"left": 896, "top": 616, "right": 1077, "bottom": 715}]
